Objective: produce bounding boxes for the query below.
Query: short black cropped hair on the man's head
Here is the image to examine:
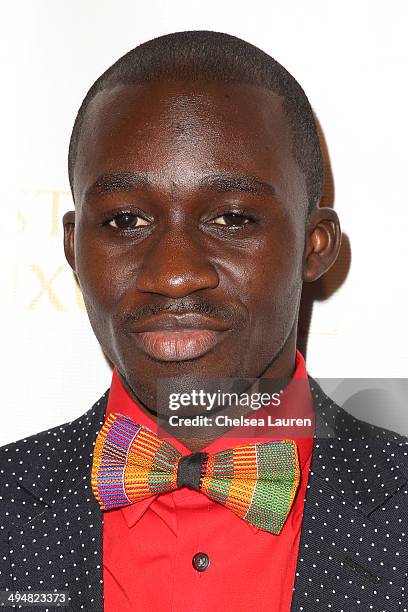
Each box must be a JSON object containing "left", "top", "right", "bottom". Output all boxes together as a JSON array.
[{"left": 68, "top": 30, "right": 323, "bottom": 211}]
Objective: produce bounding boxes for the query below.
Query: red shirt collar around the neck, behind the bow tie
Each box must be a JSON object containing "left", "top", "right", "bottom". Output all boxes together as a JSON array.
[{"left": 105, "top": 350, "right": 315, "bottom": 532}]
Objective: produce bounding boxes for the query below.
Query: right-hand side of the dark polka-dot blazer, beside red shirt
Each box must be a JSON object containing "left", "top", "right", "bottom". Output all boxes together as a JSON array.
[{"left": 291, "top": 379, "right": 408, "bottom": 612}]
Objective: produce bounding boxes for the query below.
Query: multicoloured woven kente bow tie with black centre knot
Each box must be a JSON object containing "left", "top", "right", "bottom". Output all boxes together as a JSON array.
[{"left": 91, "top": 413, "right": 300, "bottom": 534}]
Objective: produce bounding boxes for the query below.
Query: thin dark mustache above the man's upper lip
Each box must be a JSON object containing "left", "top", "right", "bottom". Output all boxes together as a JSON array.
[{"left": 121, "top": 298, "right": 242, "bottom": 325}]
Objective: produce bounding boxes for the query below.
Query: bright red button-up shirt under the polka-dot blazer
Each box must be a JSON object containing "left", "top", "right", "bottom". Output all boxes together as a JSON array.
[{"left": 103, "top": 352, "right": 314, "bottom": 612}]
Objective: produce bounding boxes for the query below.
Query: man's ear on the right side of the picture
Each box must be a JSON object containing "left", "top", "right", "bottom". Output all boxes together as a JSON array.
[{"left": 303, "top": 207, "right": 341, "bottom": 283}]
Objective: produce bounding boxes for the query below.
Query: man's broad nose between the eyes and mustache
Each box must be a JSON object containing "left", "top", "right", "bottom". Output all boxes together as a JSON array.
[{"left": 137, "top": 229, "right": 219, "bottom": 298}]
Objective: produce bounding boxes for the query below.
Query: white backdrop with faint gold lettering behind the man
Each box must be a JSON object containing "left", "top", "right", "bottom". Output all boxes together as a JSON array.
[{"left": 0, "top": 0, "right": 408, "bottom": 444}]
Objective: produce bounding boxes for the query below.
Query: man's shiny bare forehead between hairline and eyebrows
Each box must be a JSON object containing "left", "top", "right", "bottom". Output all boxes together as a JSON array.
[{"left": 74, "top": 81, "right": 304, "bottom": 206}]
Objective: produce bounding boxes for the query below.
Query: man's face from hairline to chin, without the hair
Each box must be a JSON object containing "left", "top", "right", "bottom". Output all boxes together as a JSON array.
[{"left": 66, "top": 82, "right": 308, "bottom": 405}]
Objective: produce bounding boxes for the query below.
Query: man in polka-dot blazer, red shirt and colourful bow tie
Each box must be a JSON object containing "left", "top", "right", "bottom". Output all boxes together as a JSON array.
[{"left": 0, "top": 32, "right": 408, "bottom": 612}]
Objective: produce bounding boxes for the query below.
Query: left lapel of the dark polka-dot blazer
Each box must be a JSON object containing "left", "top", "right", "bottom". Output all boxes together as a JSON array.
[{"left": 8, "top": 393, "right": 107, "bottom": 612}]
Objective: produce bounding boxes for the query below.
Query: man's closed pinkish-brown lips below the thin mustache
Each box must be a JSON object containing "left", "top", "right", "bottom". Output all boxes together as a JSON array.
[{"left": 128, "top": 314, "right": 229, "bottom": 361}]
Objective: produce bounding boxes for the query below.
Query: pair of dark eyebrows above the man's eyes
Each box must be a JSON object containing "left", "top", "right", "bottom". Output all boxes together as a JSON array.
[{"left": 85, "top": 172, "right": 276, "bottom": 199}]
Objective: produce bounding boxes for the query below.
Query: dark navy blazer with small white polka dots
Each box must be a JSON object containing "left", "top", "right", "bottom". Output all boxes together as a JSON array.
[{"left": 0, "top": 378, "right": 408, "bottom": 612}]
